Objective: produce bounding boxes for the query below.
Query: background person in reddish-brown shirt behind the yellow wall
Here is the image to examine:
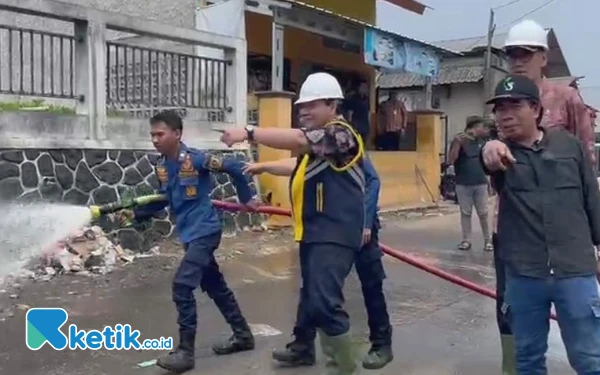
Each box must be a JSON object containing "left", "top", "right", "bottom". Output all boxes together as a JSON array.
[{"left": 376, "top": 93, "right": 408, "bottom": 151}]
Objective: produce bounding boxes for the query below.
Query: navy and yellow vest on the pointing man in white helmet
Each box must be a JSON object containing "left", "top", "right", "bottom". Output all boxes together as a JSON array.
[{"left": 290, "top": 120, "right": 366, "bottom": 250}]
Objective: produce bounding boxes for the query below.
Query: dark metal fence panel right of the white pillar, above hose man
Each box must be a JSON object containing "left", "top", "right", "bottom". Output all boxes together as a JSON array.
[{"left": 106, "top": 42, "right": 229, "bottom": 120}]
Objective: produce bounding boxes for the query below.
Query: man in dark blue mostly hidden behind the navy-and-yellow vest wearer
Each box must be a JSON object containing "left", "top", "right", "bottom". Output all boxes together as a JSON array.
[{"left": 245, "top": 158, "right": 394, "bottom": 370}]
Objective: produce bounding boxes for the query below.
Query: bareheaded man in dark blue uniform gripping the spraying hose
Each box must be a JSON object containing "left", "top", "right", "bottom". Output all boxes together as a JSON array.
[{"left": 121, "top": 111, "right": 254, "bottom": 373}]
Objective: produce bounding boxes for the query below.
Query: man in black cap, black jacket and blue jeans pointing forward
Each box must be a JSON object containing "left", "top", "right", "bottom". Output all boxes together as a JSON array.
[{"left": 482, "top": 76, "right": 600, "bottom": 375}]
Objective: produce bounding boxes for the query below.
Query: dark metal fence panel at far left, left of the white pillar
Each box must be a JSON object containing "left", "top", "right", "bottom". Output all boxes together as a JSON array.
[{"left": 0, "top": 25, "right": 75, "bottom": 98}]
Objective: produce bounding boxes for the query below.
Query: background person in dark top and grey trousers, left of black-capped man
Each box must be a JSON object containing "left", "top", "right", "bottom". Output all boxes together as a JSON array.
[{"left": 448, "top": 116, "right": 494, "bottom": 251}]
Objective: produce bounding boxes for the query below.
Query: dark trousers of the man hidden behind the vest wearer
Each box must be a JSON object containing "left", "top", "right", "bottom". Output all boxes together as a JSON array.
[{"left": 294, "top": 232, "right": 392, "bottom": 347}]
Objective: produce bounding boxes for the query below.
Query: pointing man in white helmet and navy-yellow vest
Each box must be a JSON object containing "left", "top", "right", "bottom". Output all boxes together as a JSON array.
[{"left": 221, "top": 73, "right": 365, "bottom": 375}]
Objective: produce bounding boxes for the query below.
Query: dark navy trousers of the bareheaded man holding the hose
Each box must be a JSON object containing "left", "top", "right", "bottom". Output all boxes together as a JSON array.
[{"left": 173, "top": 232, "right": 248, "bottom": 334}]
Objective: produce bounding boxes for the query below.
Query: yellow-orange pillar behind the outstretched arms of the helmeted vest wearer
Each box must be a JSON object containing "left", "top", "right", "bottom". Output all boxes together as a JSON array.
[{"left": 256, "top": 91, "right": 295, "bottom": 227}]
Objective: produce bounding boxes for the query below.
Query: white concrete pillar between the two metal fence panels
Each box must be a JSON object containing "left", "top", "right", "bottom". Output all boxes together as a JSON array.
[{"left": 75, "top": 21, "right": 107, "bottom": 140}]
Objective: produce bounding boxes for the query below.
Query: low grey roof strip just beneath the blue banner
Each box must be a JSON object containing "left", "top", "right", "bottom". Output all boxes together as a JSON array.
[{"left": 377, "top": 63, "right": 484, "bottom": 89}]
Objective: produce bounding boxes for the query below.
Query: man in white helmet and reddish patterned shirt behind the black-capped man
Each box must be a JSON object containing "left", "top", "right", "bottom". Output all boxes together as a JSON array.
[{"left": 483, "top": 20, "right": 595, "bottom": 375}]
